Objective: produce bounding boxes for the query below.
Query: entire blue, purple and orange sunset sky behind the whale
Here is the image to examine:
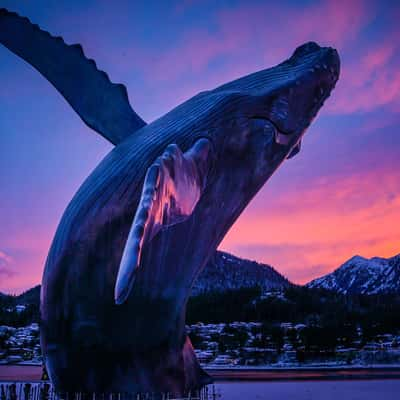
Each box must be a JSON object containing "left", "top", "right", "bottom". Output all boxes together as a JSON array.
[{"left": 0, "top": 0, "right": 400, "bottom": 293}]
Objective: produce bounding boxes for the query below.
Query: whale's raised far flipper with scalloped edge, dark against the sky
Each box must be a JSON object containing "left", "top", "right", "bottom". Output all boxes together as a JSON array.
[{"left": 0, "top": 8, "right": 146, "bottom": 144}]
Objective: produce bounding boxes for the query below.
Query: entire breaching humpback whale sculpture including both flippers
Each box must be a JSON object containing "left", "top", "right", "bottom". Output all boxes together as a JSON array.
[{"left": 0, "top": 9, "right": 339, "bottom": 395}]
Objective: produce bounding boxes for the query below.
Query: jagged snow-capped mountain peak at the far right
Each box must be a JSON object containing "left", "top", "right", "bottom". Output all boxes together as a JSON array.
[{"left": 306, "top": 254, "right": 400, "bottom": 294}]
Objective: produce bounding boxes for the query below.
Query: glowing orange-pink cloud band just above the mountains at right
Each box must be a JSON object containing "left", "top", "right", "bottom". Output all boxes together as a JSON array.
[{"left": 221, "top": 168, "right": 400, "bottom": 283}]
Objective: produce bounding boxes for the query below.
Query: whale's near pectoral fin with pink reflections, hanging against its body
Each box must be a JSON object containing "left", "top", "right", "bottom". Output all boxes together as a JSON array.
[{"left": 114, "top": 138, "right": 211, "bottom": 304}]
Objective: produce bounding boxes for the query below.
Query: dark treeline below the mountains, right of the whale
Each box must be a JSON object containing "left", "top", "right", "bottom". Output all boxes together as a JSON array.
[{"left": 187, "top": 286, "right": 400, "bottom": 338}]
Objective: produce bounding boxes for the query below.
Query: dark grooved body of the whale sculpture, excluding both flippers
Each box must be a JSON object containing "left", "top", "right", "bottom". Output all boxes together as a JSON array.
[{"left": 0, "top": 6, "right": 339, "bottom": 394}]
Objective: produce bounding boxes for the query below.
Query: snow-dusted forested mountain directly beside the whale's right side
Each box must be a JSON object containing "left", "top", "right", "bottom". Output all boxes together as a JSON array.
[{"left": 192, "top": 251, "right": 291, "bottom": 295}]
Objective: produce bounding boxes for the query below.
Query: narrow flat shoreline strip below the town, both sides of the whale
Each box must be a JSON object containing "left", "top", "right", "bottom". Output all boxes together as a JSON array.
[{"left": 0, "top": 364, "right": 400, "bottom": 383}]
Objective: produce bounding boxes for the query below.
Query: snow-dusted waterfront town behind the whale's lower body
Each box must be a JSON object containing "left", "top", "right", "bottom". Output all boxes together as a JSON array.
[{"left": 0, "top": 316, "right": 400, "bottom": 368}]
